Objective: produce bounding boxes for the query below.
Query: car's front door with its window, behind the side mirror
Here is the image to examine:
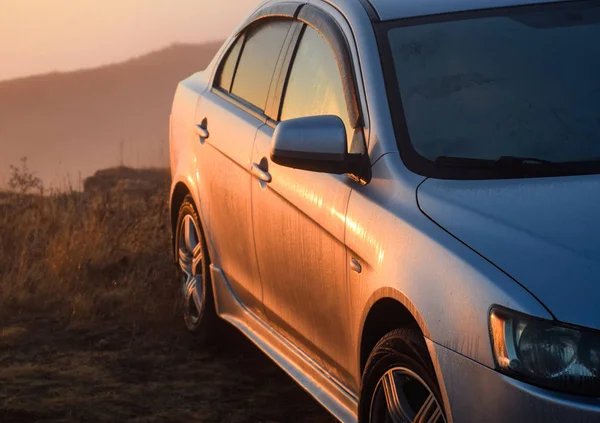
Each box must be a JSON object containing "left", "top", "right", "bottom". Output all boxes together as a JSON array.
[{"left": 252, "top": 24, "right": 354, "bottom": 384}]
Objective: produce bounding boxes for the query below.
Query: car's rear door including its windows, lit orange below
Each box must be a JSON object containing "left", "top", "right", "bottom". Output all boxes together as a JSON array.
[{"left": 195, "top": 19, "right": 292, "bottom": 315}]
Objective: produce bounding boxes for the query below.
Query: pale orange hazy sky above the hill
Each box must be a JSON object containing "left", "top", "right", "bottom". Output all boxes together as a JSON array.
[{"left": 0, "top": 0, "right": 259, "bottom": 80}]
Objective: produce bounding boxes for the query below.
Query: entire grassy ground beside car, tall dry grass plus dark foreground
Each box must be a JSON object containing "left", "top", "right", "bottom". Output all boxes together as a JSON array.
[{"left": 0, "top": 169, "right": 333, "bottom": 423}]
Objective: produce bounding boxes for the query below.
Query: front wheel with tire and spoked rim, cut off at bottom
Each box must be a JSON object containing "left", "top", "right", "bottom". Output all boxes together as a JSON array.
[{"left": 359, "top": 328, "right": 447, "bottom": 423}]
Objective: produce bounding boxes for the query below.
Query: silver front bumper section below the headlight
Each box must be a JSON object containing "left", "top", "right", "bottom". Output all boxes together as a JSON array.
[{"left": 428, "top": 341, "right": 600, "bottom": 423}]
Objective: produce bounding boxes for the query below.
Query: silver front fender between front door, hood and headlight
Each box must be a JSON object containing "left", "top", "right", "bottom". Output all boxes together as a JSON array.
[{"left": 346, "top": 155, "right": 552, "bottom": 368}]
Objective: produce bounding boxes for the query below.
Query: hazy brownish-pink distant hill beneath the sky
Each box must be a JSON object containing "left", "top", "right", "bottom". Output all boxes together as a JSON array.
[{"left": 0, "top": 42, "right": 221, "bottom": 187}]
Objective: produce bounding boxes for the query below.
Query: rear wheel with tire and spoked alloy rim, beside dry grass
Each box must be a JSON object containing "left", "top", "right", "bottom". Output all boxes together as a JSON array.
[{"left": 174, "top": 195, "right": 220, "bottom": 343}]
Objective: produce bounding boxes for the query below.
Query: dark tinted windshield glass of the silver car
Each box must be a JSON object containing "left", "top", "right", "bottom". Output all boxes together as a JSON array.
[{"left": 380, "top": 1, "right": 600, "bottom": 177}]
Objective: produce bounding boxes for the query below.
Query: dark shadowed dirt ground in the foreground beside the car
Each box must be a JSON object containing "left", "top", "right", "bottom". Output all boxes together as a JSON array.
[{"left": 0, "top": 316, "right": 335, "bottom": 423}]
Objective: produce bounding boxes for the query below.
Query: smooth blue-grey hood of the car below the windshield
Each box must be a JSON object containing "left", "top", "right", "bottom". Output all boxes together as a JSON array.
[{"left": 417, "top": 175, "right": 600, "bottom": 329}]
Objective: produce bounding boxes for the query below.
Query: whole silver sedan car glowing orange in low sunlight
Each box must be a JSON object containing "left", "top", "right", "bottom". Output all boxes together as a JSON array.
[{"left": 170, "top": 0, "right": 600, "bottom": 423}]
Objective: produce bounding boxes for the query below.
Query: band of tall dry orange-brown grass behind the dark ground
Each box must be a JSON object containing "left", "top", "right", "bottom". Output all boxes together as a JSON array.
[{"left": 0, "top": 168, "right": 176, "bottom": 322}]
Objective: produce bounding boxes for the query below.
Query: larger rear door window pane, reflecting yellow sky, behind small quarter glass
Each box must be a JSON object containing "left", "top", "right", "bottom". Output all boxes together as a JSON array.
[{"left": 227, "top": 19, "right": 293, "bottom": 110}]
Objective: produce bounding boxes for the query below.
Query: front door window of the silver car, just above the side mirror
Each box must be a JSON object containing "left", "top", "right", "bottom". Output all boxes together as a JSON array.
[{"left": 280, "top": 26, "right": 354, "bottom": 146}]
